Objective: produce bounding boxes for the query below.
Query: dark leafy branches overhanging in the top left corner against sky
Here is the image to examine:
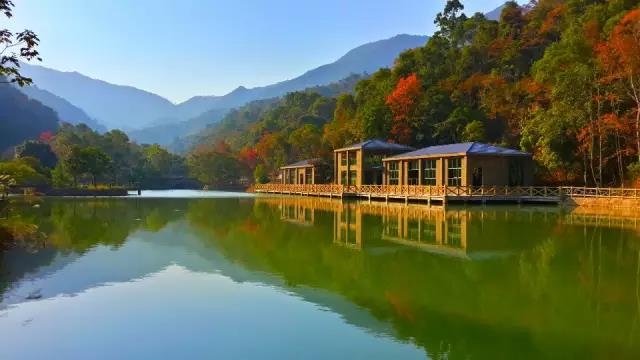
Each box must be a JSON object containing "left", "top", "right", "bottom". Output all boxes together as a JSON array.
[{"left": 0, "top": 0, "right": 42, "bottom": 86}]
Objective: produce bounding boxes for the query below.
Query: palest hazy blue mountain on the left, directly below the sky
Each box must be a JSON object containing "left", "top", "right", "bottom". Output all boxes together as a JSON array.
[{"left": 21, "top": 64, "right": 175, "bottom": 129}]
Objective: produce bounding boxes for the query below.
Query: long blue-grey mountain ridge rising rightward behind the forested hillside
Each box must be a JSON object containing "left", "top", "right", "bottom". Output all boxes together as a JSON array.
[{"left": 178, "top": 34, "right": 429, "bottom": 113}]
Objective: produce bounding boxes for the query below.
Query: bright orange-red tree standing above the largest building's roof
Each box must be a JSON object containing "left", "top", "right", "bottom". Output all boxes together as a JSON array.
[{"left": 386, "top": 73, "right": 423, "bottom": 143}]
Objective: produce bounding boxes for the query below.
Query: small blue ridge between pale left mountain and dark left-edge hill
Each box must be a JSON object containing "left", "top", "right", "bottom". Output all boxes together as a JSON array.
[{"left": 19, "top": 85, "right": 106, "bottom": 132}]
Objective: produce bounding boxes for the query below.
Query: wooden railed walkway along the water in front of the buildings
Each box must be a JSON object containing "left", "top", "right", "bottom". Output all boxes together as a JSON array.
[{"left": 254, "top": 184, "right": 640, "bottom": 205}]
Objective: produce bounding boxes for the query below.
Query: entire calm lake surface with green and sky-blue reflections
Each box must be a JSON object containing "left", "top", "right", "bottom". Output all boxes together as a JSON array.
[{"left": 0, "top": 192, "right": 640, "bottom": 359}]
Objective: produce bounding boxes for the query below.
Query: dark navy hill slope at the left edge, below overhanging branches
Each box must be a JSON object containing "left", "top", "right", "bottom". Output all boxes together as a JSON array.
[{"left": 0, "top": 84, "right": 60, "bottom": 151}]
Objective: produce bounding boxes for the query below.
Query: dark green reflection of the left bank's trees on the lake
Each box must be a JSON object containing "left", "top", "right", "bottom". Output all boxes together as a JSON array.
[{"left": 0, "top": 199, "right": 187, "bottom": 300}]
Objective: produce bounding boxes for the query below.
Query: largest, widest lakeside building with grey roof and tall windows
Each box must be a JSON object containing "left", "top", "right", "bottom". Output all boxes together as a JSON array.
[{"left": 383, "top": 142, "right": 533, "bottom": 186}]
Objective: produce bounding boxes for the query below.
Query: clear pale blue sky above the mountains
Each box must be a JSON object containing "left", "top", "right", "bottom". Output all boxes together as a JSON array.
[{"left": 8, "top": 0, "right": 504, "bottom": 103}]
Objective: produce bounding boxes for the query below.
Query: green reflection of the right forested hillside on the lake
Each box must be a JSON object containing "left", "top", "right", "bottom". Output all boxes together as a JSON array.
[{"left": 189, "top": 198, "right": 640, "bottom": 358}]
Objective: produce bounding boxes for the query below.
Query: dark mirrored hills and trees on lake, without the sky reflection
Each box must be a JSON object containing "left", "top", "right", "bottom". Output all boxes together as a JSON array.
[{"left": 0, "top": 197, "right": 640, "bottom": 358}]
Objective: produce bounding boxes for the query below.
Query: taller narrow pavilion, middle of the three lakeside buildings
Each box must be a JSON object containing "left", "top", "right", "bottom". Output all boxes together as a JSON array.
[{"left": 333, "top": 139, "right": 414, "bottom": 186}]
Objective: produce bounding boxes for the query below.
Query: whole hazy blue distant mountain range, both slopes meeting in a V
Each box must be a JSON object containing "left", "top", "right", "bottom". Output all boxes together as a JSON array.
[{"left": 16, "top": 35, "right": 428, "bottom": 140}]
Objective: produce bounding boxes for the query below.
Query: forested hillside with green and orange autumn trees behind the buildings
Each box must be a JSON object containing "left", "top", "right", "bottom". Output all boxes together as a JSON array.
[{"left": 191, "top": 0, "right": 640, "bottom": 186}]
